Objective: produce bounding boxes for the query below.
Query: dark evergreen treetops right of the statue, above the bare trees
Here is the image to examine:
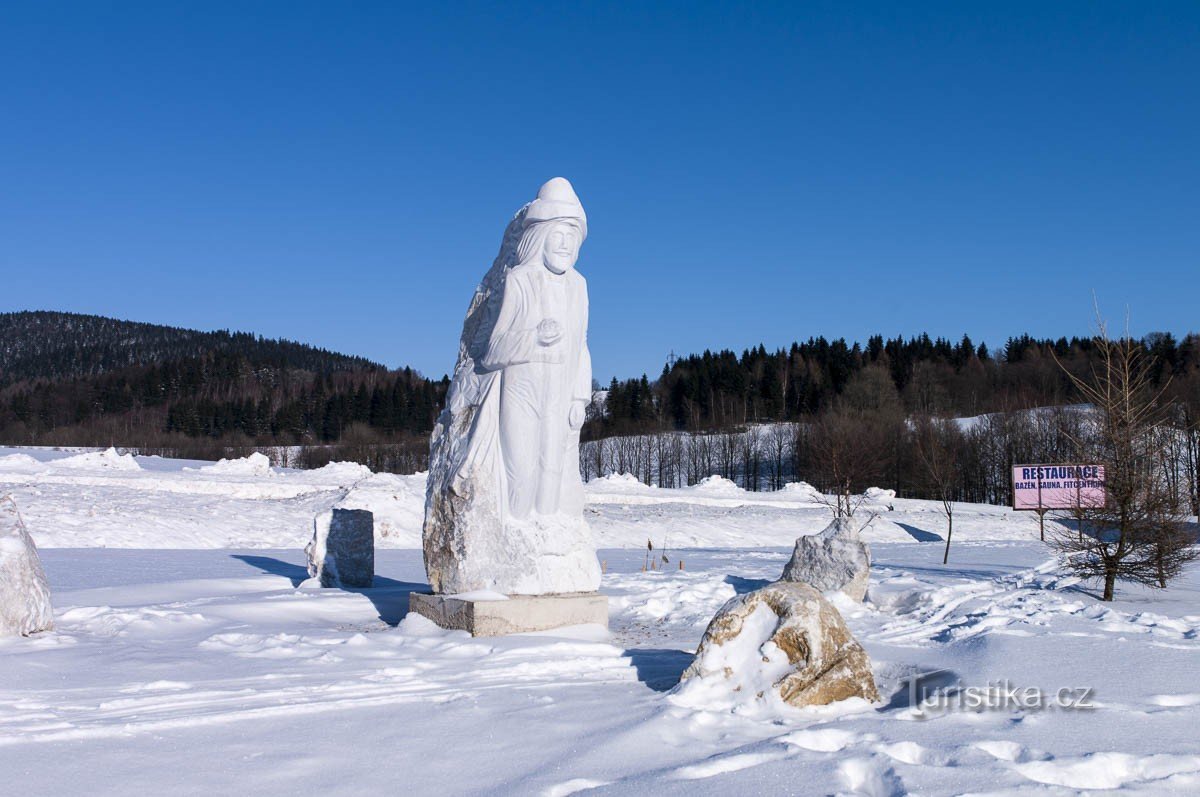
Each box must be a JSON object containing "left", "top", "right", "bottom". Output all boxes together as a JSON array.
[{"left": 584, "top": 332, "right": 1200, "bottom": 439}]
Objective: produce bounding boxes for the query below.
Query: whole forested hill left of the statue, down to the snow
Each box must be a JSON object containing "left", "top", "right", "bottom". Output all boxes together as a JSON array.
[{"left": 0, "top": 312, "right": 448, "bottom": 468}]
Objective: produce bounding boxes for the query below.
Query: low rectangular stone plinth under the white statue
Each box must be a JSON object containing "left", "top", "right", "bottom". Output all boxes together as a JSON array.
[{"left": 408, "top": 592, "right": 608, "bottom": 636}]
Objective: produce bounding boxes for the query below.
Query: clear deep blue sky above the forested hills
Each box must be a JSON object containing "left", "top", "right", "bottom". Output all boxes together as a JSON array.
[{"left": 0, "top": 0, "right": 1200, "bottom": 380}]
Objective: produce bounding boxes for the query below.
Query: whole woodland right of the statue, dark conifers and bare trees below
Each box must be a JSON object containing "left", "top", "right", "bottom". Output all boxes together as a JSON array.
[{"left": 580, "top": 335, "right": 1200, "bottom": 514}]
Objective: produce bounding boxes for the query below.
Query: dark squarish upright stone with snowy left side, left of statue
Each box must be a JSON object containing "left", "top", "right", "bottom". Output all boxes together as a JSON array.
[{"left": 304, "top": 508, "right": 374, "bottom": 587}]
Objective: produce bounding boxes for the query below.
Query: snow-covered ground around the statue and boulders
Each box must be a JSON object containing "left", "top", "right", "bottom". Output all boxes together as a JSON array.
[{"left": 0, "top": 450, "right": 1200, "bottom": 795}]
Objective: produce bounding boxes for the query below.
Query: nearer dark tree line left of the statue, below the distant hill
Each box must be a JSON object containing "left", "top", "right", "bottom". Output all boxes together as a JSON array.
[{"left": 0, "top": 352, "right": 446, "bottom": 447}]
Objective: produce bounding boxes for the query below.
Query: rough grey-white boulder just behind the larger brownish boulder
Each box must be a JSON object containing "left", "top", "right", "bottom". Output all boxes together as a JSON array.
[{"left": 780, "top": 517, "right": 871, "bottom": 600}]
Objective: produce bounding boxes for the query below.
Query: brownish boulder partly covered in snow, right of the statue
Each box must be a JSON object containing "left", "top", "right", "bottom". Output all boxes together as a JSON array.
[{"left": 676, "top": 581, "right": 880, "bottom": 711}]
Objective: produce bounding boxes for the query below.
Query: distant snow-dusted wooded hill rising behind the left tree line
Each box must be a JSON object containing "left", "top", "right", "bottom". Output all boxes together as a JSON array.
[{"left": 0, "top": 311, "right": 383, "bottom": 386}]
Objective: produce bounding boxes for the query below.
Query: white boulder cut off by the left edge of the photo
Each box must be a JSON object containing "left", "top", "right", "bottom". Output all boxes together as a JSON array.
[{"left": 0, "top": 496, "right": 54, "bottom": 636}]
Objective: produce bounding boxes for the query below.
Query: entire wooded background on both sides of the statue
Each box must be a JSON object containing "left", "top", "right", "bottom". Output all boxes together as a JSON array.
[{"left": 0, "top": 312, "right": 1200, "bottom": 511}]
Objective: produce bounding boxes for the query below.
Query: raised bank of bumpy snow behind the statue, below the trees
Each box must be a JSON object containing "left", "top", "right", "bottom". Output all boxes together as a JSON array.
[{"left": 0, "top": 449, "right": 1051, "bottom": 550}]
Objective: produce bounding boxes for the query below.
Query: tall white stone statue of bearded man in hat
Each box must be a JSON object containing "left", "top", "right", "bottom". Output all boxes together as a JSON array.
[{"left": 424, "top": 178, "right": 600, "bottom": 594}]
